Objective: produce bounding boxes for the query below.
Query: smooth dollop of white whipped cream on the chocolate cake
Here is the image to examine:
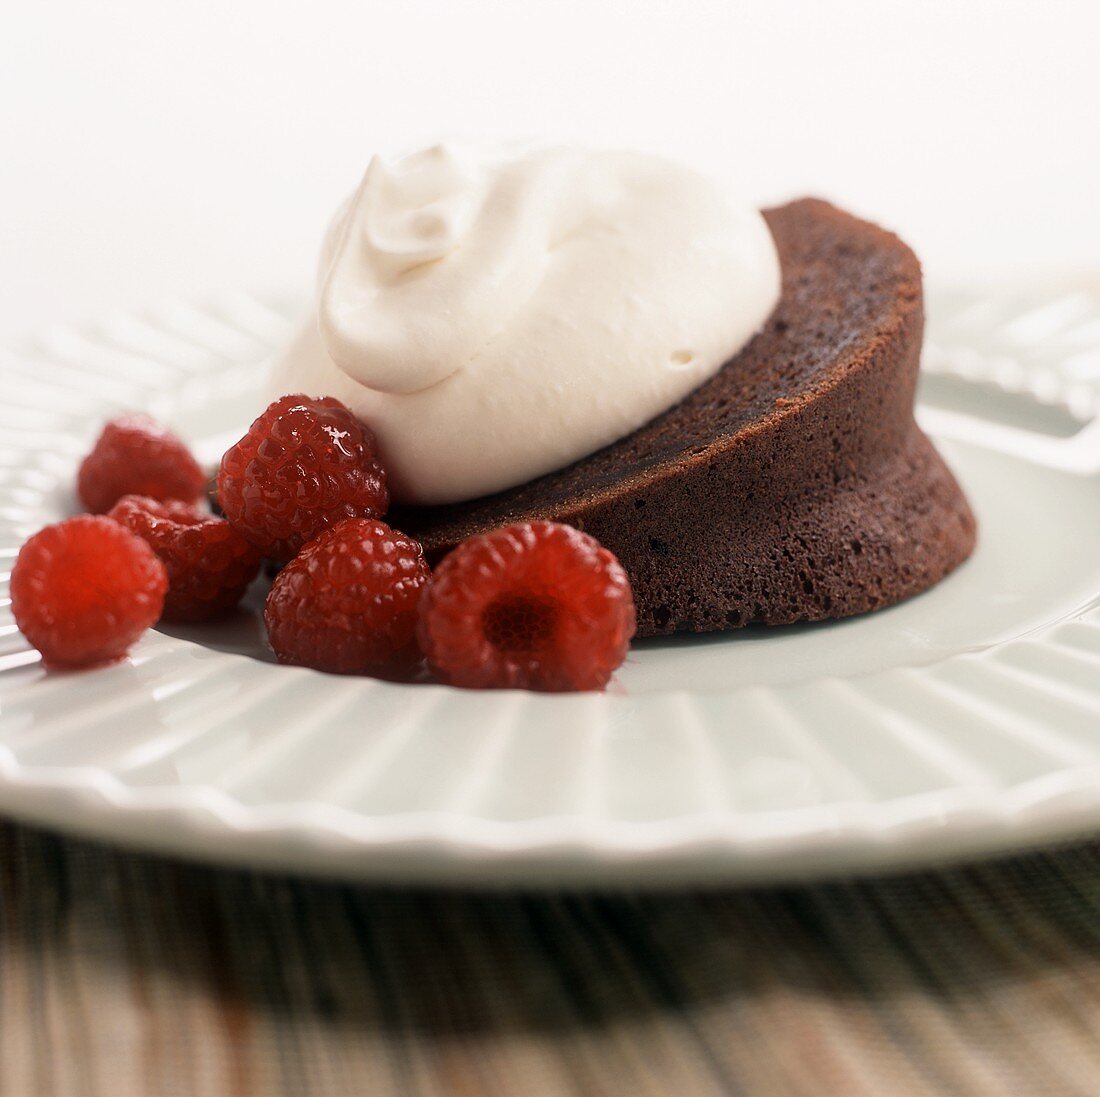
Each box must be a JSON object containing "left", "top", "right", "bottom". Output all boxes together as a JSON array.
[{"left": 270, "top": 144, "right": 780, "bottom": 503}]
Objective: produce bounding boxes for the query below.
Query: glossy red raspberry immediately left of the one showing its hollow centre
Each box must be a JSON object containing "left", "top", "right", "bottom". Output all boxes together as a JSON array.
[{"left": 264, "top": 518, "right": 431, "bottom": 674}]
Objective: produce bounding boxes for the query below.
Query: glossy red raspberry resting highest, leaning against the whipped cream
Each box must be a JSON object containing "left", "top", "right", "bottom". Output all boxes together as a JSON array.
[{"left": 218, "top": 395, "right": 389, "bottom": 561}]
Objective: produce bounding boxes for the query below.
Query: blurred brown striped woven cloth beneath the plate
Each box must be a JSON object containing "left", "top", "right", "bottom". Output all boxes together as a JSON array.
[{"left": 0, "top": 824, "right": 1100, "bottom": 1097}]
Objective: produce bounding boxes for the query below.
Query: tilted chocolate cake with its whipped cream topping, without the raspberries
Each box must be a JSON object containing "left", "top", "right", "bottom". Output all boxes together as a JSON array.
[{"left": 270, "top": 139, "right": 976, "bottom": 636}]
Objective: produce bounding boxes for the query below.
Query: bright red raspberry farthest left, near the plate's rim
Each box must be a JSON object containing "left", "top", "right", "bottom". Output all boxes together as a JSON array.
[{"left": 11, "top": 515, "right": 168, "bottom": 667}]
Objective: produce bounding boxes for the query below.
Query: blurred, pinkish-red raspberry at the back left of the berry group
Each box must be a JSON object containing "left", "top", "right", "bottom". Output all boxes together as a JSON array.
[{"left": 76, "top": 415, "right": 206, "bottom": 514}]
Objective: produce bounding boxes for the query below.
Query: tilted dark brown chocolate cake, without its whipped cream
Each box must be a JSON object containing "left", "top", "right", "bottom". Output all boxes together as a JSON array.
[{"left": 391, "top": 199, "right": 976, "bottom": 636}]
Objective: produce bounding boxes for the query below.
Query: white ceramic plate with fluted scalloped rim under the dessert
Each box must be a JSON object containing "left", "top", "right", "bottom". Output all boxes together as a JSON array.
[{"left": 0, "top": 283, "right": 1100, "bottom": 884}]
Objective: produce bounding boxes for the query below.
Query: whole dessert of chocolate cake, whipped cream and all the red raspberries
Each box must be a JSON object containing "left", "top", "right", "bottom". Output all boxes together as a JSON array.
[{"left": 11, "top": 134, "right": 976, "bottom": 691}]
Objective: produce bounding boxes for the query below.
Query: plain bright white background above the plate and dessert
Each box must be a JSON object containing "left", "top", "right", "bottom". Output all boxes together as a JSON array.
[{"left": 0, "top": 0, "right": 1100, "bottom": 337}]
